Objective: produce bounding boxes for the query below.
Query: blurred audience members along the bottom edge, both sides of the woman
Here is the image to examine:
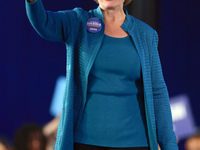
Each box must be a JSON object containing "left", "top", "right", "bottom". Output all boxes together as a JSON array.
[{"left": 0, "top": 117, "right": 200, "bottom": 150}]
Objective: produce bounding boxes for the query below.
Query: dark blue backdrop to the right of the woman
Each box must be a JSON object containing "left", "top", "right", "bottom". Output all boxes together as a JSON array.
[{"left": 159, "top": 0, "right": 200, "bottom": 149}]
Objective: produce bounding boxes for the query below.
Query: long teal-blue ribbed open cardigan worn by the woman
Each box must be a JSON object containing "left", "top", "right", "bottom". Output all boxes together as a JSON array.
[{"left": 26, "top": 0, "right": 178, "bottom": 150}]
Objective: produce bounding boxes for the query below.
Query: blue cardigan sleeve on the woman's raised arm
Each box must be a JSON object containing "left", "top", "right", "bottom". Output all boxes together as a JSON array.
[{"left": 25, "top": 0, "right": 77, "bottom": 42}]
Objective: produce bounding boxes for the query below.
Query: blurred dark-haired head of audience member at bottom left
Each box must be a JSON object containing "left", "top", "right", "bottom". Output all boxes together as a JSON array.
[{"left": 14, "top": 124, "right": 46, "bottom": 150}]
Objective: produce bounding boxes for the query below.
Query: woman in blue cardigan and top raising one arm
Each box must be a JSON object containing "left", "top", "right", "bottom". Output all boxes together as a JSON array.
[{"left": 26, "top": 0, "right": 178, "bottom": 150}]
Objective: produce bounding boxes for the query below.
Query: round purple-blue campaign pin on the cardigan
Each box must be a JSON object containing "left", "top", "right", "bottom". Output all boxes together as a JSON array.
[{"left": 87, "top": 18, "right": 102, "bottom": 33}]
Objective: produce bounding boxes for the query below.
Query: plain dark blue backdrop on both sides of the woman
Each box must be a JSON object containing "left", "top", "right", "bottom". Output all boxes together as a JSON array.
[{"left": 0, "top": 0, "right": 200, "bottom": 149}]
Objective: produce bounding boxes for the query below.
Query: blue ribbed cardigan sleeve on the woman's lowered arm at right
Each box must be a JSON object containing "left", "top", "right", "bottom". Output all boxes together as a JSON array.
[{"left": 151, "top": 31, "right": 178, "bottom": 150}]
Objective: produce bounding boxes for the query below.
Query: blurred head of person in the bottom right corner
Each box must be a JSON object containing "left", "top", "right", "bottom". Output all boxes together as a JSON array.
[{"left": 185, "top": 134, "right": 200, "bottom": 150}]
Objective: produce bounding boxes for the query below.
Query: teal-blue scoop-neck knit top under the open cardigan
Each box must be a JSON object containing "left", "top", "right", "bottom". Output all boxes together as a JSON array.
[{"left": 75, "top": 35, "right": 148, "bottom": 147}]
